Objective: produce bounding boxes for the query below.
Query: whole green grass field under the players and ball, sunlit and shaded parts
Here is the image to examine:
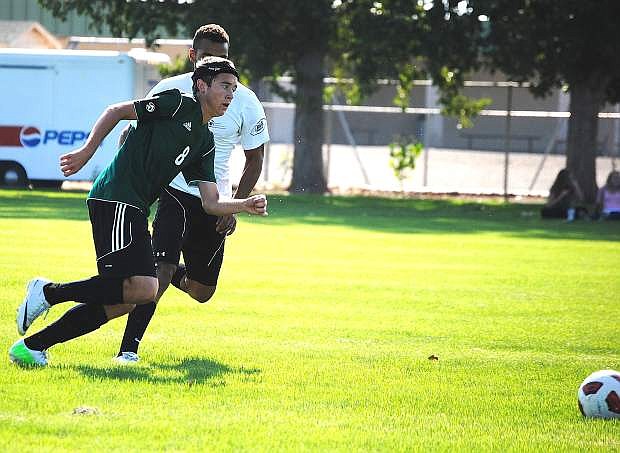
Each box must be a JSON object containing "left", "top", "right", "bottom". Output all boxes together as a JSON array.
[{"left": 0, "top": 191, "right": 620, "bottom": 452}]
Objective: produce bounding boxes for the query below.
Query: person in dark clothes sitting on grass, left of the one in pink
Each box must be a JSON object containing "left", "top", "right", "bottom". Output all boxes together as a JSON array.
[{"left": 540, "top": 168, "right": 587, "bottom": 221}]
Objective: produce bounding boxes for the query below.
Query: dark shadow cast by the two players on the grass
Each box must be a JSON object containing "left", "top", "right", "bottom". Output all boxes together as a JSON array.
[{"left": 71, "top": 357, "right": 261, "bottom": 386}]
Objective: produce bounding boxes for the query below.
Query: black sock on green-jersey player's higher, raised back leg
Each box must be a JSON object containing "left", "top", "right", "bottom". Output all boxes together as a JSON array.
[{"left": 43, "top": 276, "right": 124, "bottom": 305}]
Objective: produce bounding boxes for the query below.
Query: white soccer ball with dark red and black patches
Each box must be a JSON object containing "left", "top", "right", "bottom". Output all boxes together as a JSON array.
[{"left": 577, "top": 370, "right": 620, "bottom": 418}]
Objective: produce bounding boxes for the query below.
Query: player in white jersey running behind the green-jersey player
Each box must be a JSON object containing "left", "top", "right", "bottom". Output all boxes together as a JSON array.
[{"left": 115, "top": 24, "right": 269, "bottom": 364}]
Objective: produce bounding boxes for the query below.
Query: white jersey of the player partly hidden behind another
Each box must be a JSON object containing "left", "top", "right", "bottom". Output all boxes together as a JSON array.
[{"left": 147, "top": 72, "right": 269, "bottom": 198}]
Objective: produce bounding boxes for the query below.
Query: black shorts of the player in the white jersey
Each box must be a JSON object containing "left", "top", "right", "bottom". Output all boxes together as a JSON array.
[{"left": 153, "top": 187, "right": 226, "bottom": 286}]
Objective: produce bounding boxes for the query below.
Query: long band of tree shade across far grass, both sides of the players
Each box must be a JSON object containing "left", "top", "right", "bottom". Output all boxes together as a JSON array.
[{"left": 0, "top": 190, "right": 620, "bottom": 241}]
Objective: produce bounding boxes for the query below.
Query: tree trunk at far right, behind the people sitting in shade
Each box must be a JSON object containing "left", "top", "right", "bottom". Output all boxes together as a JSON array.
[{"left": 566, "top": 76, "right": 608, "bottom": 203}]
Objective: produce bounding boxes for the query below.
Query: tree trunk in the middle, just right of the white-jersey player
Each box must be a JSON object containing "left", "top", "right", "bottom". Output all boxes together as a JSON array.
[{"left": 289, "top": 50, "right": 327, "bottom": 193}]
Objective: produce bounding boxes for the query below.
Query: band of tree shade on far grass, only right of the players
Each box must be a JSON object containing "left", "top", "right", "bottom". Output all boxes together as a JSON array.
[{"left": 252, "top": 195, "right": 620, "bottom": 241}]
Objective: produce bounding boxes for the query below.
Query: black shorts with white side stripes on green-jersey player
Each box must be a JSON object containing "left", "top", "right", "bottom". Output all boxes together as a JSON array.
[{"left": 87, "top": 198, "right": 156, "bottom": 278}]
